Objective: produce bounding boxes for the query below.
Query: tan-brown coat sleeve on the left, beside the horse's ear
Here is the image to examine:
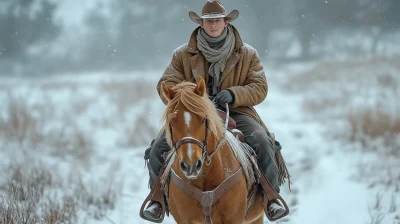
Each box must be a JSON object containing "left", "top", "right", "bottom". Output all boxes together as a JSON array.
[{"left": 157, "top": 49, "right": 185, "bottom": 105}]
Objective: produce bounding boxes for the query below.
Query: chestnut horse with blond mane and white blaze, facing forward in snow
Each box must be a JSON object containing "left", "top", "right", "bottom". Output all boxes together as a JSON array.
[{"left": 161, "top": 77, "right": 264, "bottom": 224}]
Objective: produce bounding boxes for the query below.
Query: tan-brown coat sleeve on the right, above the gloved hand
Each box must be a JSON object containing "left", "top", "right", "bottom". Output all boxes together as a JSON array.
[{"left": 228, "top": 49, "right": 268, "bottom": 108}]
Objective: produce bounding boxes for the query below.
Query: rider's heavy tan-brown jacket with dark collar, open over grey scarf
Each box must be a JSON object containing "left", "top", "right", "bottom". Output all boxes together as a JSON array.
[{"left": 157, "top": 26, "right": 268, "bottom": 131}]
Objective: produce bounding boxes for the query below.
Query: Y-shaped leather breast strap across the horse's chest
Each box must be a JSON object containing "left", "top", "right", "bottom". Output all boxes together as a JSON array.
[{"left": 171, "top": 168, "right": 244, "bottom": 224}]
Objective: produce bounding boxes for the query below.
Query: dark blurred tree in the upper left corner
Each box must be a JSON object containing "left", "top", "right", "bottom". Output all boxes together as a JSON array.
[{"left": 0, "top": 0, "right": 60, "bottom": 61}]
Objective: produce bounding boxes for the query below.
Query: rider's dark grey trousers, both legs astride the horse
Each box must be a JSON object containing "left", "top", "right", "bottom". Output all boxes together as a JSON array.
[{"left": 148, "top": 112, "right": 279, "bottom": 192}]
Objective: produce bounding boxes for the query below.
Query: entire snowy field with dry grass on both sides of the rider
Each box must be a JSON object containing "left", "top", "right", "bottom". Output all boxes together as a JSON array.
[{"left": 0, "top": 55, "right": 400, "bottom": 224}]
